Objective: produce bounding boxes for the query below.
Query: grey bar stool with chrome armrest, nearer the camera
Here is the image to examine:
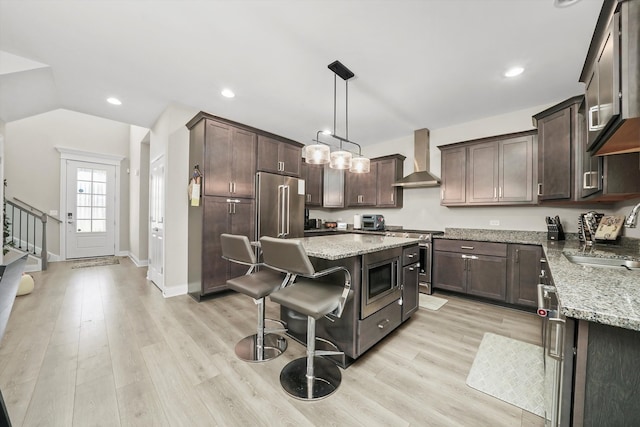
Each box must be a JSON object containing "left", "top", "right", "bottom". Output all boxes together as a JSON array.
[{"left": 260, "top": 237, "right": 351, "bottom": 400}]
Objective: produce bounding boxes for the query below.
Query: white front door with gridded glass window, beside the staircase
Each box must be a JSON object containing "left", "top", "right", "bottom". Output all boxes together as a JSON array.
[{"left": 64, "top": 160, "right": 116, "bottom": 258}]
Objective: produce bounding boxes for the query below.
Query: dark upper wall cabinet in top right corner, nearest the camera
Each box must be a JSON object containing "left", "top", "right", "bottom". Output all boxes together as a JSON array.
[{"left": 580, "top": 0, "right": 640, "bottom": 155}]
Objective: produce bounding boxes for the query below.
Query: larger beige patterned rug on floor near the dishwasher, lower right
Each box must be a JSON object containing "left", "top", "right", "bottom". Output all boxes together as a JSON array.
[{"left": 467, "top": 332, "right": 544, "bottom": 417}]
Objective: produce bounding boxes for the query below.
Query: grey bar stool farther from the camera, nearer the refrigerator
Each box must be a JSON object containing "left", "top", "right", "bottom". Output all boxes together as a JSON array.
[{"left": 220, "top": 234, "right": 288, "bottom": 362}]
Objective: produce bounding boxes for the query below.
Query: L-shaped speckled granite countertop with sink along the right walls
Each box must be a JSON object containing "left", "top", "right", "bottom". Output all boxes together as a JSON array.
[{"left": 434, "top": 229, "right": 640, "bottom": 331}]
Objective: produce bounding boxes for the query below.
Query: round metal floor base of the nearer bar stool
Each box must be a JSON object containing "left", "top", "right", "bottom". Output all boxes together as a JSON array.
[{"left": 280, "top": 356, "right": 342, "bottom": 400}]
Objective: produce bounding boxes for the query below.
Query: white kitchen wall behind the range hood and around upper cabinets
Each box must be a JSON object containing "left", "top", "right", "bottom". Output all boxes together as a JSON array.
[{"left": 310, "top": 105, "right": 640, "bottom": 237}]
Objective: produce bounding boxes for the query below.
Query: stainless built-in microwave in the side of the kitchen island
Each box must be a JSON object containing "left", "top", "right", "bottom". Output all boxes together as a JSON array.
[{"left": 360, "top": 248, "right": 402, "bottom": 319}]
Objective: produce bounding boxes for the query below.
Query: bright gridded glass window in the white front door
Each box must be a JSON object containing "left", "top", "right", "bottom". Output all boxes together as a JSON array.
[{"left": 76, "top": 168, "right": 107, "bottom": 233}]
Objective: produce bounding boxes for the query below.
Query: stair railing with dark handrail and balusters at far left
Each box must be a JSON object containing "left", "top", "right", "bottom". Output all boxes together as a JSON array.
[{"left": 4, "top": 197, "right": 62, "bottom": 271}]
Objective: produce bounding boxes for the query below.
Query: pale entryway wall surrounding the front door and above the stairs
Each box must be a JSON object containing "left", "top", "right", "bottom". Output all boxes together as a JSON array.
[{"left": 5, "top": 109, "right": 129, "bottom": 255}]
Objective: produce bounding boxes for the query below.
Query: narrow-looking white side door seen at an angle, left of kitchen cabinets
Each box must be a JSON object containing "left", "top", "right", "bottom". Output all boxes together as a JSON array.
[{"left": 147, "top": 157, "right": 164, "bottom": 291}]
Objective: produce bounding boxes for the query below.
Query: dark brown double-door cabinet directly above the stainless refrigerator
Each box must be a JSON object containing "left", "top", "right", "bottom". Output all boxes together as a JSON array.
[{"left": 258, "top": 135, "right": 302, "bottom": 177}]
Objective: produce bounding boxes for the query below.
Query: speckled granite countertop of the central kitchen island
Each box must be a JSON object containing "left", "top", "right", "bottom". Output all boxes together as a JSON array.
[{"left": 292, "top": 233, "right": 419, "bottom": 260}]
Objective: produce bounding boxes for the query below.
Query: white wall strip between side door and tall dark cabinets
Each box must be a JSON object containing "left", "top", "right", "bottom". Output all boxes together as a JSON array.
[{"left": 149, "top": 105, "right": 199, "bottom": 296}]
